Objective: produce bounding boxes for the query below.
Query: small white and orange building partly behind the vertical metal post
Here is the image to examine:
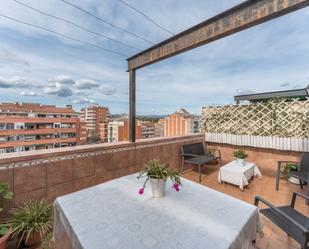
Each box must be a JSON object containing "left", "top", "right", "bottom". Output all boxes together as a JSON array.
[{"left": 108, "top": 119, "right": 142, "bottom": 142}]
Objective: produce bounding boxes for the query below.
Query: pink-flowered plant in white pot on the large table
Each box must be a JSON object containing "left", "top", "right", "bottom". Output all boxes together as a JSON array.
[{"left": 137, "top": 160, "right": 181, "bottom": 197}]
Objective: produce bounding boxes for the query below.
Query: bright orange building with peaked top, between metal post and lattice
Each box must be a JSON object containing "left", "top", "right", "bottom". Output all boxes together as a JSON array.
[{"left": 161, "top": 108, "right": 199, "bottom": 136}]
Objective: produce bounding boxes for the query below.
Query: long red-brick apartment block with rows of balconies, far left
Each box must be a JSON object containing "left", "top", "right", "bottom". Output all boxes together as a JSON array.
[{"left": 0, "top": 103, "right": 86, "bottom": 153}]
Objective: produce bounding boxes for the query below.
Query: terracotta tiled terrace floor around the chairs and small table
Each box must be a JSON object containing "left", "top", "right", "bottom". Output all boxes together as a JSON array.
[{"left": 183, "top": 163, "right": 309, "bottom": 249}]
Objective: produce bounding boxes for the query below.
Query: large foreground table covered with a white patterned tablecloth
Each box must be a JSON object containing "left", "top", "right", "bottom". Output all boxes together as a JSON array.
[{"left": 54, "top": 174, "right": 261, "bottom": 249}]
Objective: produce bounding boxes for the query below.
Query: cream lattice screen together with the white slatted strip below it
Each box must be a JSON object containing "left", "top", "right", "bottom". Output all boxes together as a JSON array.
[{"left": 201, "top": 98, "right": 309, "bottom": 151}]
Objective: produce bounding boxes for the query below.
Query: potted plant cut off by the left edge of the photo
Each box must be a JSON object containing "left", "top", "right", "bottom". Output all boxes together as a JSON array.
[{"left": 0, "top": 182, "right": 13, "bottom": 249}]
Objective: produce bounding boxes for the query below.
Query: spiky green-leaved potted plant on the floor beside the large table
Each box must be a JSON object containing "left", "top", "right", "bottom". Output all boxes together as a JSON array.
[{"left": 8, "top": 200, "right": 53, "bottom": 247}]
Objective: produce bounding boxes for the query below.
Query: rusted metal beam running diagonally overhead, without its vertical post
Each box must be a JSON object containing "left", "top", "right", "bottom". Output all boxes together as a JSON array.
[{"left": 128, "top": 0, "right": 309, "bottom": 71}]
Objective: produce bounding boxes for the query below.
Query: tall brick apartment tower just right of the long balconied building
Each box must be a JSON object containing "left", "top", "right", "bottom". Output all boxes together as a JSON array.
[{"left": 80, "top": 105, "right": 109, "bottom": 142}]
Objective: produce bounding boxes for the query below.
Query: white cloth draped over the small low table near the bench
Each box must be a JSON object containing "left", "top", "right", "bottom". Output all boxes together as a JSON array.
[{"left": 218, "top": 160, "right": 262, "bottom": 190}]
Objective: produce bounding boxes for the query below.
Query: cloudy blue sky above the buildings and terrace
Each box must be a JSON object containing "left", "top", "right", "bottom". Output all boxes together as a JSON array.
[{"left": 0, "top": 0, "right": 309, "bottom": 115}]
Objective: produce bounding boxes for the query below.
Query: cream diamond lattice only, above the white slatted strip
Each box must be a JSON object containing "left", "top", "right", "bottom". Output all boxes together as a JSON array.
[{"left": 201, "top": 99, "right": 309, "bottom": 138}]
